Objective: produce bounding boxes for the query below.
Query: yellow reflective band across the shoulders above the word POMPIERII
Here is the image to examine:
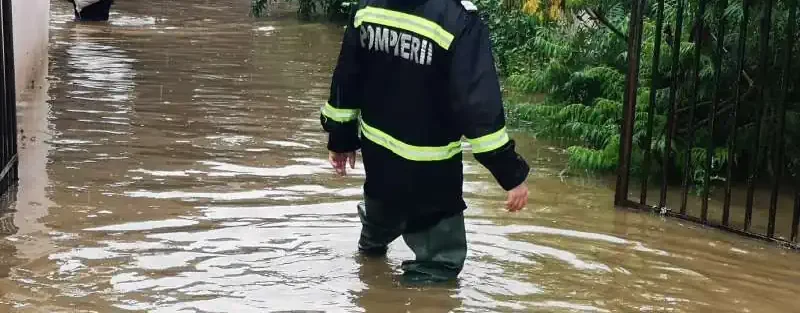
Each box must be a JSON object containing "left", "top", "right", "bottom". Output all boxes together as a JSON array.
[{"left": 353, "top": 7, "right": 454, "bottom": 50}]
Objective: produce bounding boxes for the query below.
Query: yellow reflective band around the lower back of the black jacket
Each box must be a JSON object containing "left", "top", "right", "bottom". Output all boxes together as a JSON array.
[{"left": 361, "top": 120, "right": 461, "bottom": 161}]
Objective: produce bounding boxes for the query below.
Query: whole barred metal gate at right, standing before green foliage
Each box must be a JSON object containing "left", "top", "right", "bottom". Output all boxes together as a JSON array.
[{"left": 615, "top": 0, "right": 800, "bottom": 249}]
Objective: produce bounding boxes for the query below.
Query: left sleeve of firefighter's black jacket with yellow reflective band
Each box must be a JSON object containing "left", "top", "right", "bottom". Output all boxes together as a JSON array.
[{"left": 320, "top": 7, "right": 361, "bottom": 153}]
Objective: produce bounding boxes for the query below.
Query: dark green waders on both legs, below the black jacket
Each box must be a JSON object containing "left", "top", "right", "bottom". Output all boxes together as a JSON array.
[{"left": 358, "top": 198, "right": 467, "bottom": 282}]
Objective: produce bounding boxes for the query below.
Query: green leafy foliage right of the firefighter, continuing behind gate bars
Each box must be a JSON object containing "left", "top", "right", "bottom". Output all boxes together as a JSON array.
[{"left": 490, "top": 0, "right": 800, "bottom": 188}]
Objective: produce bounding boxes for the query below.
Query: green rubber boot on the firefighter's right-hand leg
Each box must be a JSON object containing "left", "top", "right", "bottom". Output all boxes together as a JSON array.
[{"left": 402, "top": 212, "right": 467, "bottom": 284}]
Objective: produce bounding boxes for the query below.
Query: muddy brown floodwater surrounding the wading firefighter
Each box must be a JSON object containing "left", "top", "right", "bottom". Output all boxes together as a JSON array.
[{"left": 0, "top": 0, "right": 800, "bottom": 313}]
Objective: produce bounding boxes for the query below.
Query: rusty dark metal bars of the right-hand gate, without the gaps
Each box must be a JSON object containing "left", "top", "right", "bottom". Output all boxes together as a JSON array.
[{"left": 615, "top": 0, "right": 800, "bottom": 249}]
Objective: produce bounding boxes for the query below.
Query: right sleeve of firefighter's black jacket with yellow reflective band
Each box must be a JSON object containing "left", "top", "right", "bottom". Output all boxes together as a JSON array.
[{"left": 449, "top": 13, "right": 530, "bottom": 190}]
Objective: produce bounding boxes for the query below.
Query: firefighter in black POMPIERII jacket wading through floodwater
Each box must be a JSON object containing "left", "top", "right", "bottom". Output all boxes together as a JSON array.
[{"left": 320, "top": 0, "right": 530, "bottom": 282}]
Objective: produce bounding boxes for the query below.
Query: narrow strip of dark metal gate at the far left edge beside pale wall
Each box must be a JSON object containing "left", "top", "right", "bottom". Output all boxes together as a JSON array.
[{"left": 0, "top": 0, "right": 19, "bottom": 193}]
